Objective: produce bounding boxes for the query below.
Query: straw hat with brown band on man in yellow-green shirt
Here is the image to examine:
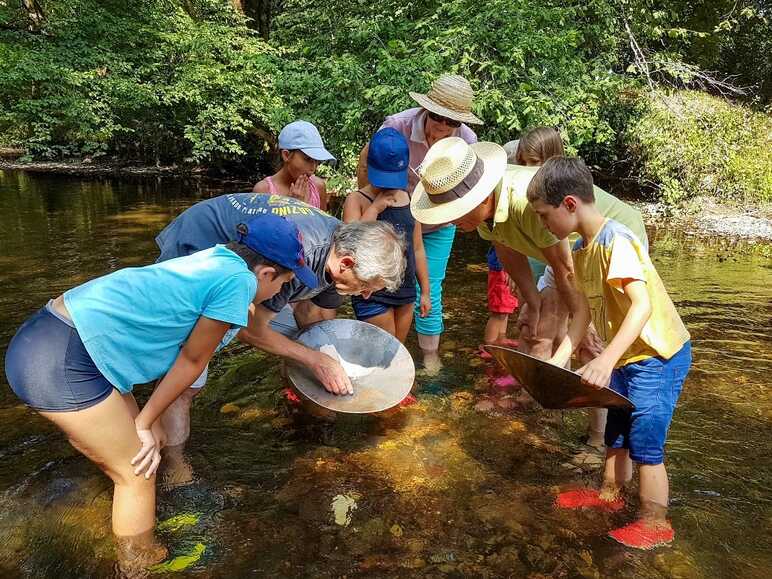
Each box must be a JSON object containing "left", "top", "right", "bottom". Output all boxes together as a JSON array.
[{"left": 410, "top": 137, "right": 507, "bottom": 225}]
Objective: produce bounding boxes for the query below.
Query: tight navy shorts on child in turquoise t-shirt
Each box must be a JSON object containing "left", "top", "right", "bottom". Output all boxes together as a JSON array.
[{"left": 5, "top": 302, "right": 113, "bottom": 412}]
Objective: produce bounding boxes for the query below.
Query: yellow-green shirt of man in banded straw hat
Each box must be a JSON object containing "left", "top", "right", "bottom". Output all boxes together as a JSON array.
[{"left": 477, "top": 165, "right": 649, "bottom": 261}]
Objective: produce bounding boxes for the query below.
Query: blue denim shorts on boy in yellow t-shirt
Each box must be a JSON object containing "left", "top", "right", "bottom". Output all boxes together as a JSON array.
[{"left": 605, "top": 342, "right": 692, "bottom": 465}]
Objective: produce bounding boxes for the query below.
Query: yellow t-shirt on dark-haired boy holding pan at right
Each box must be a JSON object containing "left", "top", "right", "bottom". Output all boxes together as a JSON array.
[{"left": 573, "top": 219, "right": 689, "bottom": 367}]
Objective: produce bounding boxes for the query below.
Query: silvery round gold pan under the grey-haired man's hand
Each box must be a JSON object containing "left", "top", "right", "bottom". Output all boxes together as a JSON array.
[{"left": 287, "top": 319, "right": 415, "bottom": 414}]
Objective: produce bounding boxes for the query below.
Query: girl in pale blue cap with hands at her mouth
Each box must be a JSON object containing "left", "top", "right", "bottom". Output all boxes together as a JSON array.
[{"left": 252, "top": 121, "right": 335, "bottom": 211}]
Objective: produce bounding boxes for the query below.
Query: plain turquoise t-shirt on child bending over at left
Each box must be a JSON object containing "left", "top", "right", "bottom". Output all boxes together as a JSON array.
[{"left": 64, "top": 245, "right": 257, "bottom": 393}]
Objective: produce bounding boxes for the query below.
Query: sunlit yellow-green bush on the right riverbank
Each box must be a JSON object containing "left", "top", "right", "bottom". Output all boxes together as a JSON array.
[{"left": 625, "top": 91, "right": 772, "bottom": 204}]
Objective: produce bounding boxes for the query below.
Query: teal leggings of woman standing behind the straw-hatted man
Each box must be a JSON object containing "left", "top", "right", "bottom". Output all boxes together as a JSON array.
[{"left": 415, "top": 225, "right": 456, "bottom": 336}]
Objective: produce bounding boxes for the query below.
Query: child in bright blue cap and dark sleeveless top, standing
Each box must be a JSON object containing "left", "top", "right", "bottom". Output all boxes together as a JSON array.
[{"left": 343, "top": 128, "right": 432, "bottom": 343}]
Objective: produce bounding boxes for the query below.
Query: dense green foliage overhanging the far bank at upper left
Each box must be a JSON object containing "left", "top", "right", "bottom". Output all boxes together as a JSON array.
[{"left": 0, "top": 0, "right": 291, "bottom": 162}]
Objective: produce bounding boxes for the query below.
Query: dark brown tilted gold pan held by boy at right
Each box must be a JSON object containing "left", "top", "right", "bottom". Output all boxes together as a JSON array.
[{"left": 485, "top": 345, "right": 635, "bottom": 410}]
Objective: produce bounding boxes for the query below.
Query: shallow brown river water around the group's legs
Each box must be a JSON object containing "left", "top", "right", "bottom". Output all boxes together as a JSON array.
[{"left": 0, "top": 171, "right": 772, "bottom": 579}]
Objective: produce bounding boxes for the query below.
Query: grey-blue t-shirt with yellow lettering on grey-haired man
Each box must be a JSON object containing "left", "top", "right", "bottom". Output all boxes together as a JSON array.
[{"left": 155, "top": 193, "right": 343, "bottom": 312}]
